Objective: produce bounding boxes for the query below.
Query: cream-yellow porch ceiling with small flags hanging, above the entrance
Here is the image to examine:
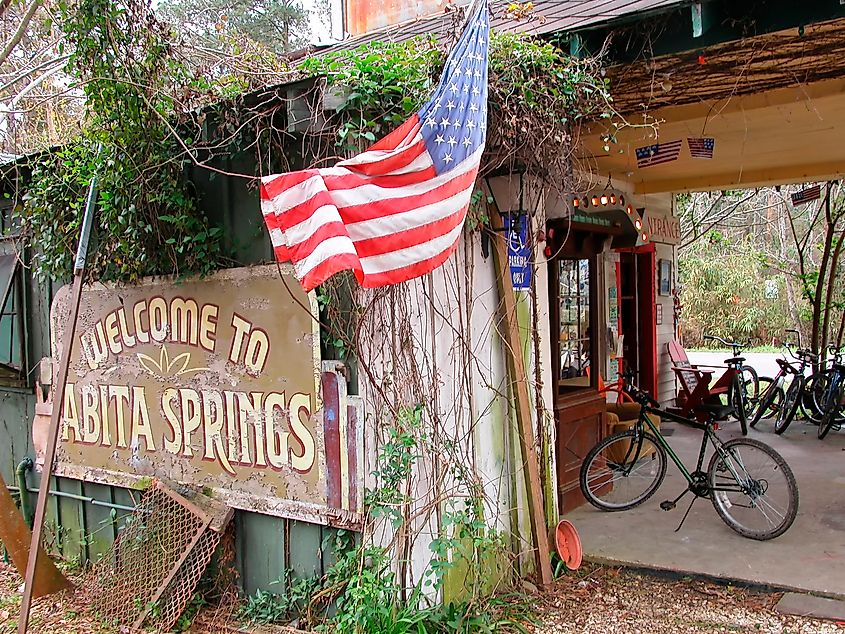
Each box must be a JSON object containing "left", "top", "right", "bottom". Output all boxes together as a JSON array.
[{"left": 581, "top": 79, "right": 845, "bottom": 194}]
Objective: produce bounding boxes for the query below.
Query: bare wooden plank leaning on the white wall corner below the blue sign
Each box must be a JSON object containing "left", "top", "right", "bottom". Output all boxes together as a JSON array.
[{"left": 488, "top": 204, "right": 553, "bottom": 586}]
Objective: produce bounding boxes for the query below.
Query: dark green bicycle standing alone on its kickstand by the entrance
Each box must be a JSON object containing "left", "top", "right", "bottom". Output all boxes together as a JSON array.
[{"left": 579, "top": 385, "right": 798, "bottom": 541}]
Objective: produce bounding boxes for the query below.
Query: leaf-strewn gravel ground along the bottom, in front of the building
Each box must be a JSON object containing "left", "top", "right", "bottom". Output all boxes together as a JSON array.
[{"left": 0, "top": 562, "right": 845, "bottom": 634}]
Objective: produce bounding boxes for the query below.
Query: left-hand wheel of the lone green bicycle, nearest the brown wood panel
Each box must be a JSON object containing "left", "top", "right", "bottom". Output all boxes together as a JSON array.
[{"left": 579, "top": 429, "right": 666, "bottom": 511}]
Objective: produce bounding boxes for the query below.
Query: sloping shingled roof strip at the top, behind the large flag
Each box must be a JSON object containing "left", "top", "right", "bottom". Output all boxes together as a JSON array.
[{"left": 326, "top": 0, "right": 692, "bottom": 50}]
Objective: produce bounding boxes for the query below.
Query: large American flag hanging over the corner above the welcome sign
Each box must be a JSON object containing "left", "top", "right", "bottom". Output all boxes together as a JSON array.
[{"left": 261, "top": 0, "right": 490, "bottom": 290}]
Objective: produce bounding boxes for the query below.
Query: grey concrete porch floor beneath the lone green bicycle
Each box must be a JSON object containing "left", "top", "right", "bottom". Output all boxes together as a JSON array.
[{"left": 566, "top": 420, "right": 845, "bottom": 598}]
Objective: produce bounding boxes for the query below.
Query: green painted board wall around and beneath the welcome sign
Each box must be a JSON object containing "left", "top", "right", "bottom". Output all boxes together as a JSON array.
[{"left": 0, "top": 135, "right": 334, "bottom": 594}]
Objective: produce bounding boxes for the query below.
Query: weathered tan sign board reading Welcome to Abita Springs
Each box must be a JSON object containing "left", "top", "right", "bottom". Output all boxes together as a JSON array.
[{"left": 51, "top": 266, "right": 363, "bottom": 528}]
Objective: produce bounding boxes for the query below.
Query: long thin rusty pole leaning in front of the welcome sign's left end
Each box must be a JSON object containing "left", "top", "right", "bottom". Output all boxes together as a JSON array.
[{"left": 18, "top": 163, "right": 100, "bottom": 634}]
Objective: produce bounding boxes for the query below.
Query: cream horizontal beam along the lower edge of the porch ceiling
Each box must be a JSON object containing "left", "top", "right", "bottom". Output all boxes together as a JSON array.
[{"left": 634, "top": 156, "right": 845, "bottom": 194}]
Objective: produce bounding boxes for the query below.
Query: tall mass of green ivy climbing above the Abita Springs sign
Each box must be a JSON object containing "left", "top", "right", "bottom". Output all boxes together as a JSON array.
[{"left": 23, "top": 0, "right": 222, "bottom": 282}]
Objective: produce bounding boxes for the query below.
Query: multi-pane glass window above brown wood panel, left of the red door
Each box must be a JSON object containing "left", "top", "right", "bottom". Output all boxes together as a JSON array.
[{"left": 557, "top": 259, "right": 594, "bottom": 388}]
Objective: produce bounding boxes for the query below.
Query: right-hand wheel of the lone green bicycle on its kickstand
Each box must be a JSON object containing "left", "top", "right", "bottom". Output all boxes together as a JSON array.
[{"left": 707, "top": 438, "right": 798, "bottom": 541}]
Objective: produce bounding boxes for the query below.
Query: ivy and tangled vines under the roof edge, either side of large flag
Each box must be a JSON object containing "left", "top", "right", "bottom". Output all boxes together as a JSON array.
[{"left": 301, "top": 33, "right": 618, "bottom": 176}]
